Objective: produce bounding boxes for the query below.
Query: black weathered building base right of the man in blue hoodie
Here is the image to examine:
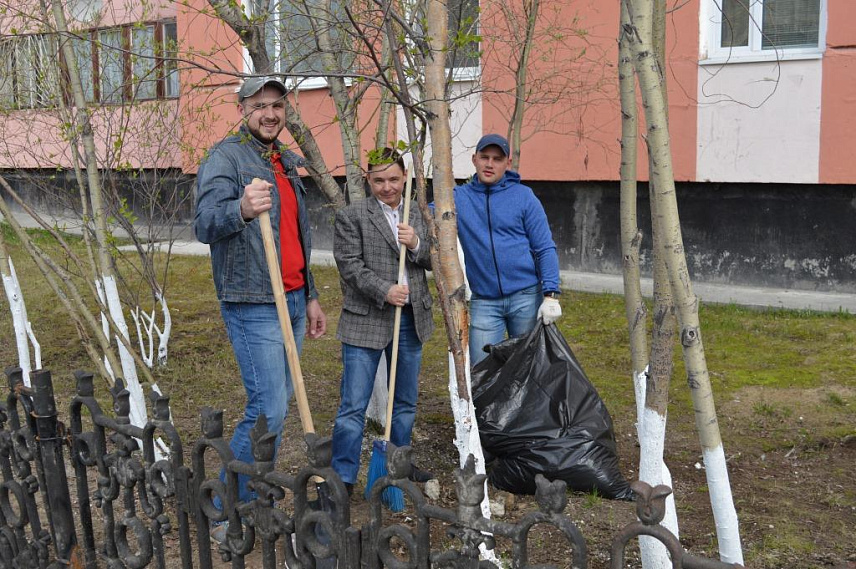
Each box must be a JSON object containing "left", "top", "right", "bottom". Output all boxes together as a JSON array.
[{"left": 534, "top": 182, "right": 856, "bottom": 293}]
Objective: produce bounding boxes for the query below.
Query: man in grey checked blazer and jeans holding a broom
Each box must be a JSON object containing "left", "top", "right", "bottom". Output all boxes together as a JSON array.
[{"left": 333, "top": 148, "right": 434, "bottom": 492}]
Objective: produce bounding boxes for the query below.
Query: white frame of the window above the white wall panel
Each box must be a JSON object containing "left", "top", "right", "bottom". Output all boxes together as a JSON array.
[{"left": 699, "top": 0, "right": 827, "bottom": 65}]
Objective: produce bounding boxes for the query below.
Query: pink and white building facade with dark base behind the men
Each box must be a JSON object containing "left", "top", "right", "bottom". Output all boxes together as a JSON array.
[{"left": 0, "top": 0, "right": 856, "bottom": 292}]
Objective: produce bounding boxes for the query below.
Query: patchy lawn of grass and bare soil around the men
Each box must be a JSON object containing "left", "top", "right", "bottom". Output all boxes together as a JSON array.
[{"left": 0, "top": 227, "right": 856, "bottom": 568}]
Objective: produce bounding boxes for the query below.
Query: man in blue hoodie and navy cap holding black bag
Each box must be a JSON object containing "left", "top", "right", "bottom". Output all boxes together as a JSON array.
[{"left": 455, "top": 134, "right": 562, "bottom": 365}]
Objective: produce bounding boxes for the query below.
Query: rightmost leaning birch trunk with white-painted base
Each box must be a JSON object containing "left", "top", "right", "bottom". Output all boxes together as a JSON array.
[{"left": 623, "top": 0, "right": 743, "bottom": 564}]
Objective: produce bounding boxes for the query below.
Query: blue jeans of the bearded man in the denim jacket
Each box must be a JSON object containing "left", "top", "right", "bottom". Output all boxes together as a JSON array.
[{"left": 215, "top": 296, "right": 306, "bottom": 506}]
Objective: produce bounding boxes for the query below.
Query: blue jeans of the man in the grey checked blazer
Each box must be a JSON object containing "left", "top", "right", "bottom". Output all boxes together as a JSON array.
[{"left": 332, "top": 309, "right": 422, "bottom": 484}]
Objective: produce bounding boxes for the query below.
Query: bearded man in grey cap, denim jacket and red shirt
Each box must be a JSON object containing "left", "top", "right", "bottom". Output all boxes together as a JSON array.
[{"left": 194, "top": 77, "right": 327, "bottom": 502}]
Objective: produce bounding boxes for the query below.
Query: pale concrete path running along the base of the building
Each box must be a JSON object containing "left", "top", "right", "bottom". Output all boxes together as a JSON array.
[{"left": 0, "top": 213, "right": 856, "bottom": 314}]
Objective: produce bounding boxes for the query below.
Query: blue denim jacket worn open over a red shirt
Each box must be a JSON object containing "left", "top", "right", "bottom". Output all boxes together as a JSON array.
[{"left": 193, "top": 125, "right": 318, "bottom": 303}]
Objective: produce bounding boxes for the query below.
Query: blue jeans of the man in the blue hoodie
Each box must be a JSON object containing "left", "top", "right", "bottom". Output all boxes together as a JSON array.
[{"left": 470, "top": 285, "right": 544, "bottom": 365}]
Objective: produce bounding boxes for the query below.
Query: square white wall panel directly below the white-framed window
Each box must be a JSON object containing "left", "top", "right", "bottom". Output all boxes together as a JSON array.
[{"left": 697, "top": 59, "right": 822, "bottom": 184}]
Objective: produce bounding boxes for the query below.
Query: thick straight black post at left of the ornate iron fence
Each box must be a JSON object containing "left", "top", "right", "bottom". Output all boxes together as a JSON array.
[{"left": 32, "top": 370, "right": 83, "bottom": 567}]
